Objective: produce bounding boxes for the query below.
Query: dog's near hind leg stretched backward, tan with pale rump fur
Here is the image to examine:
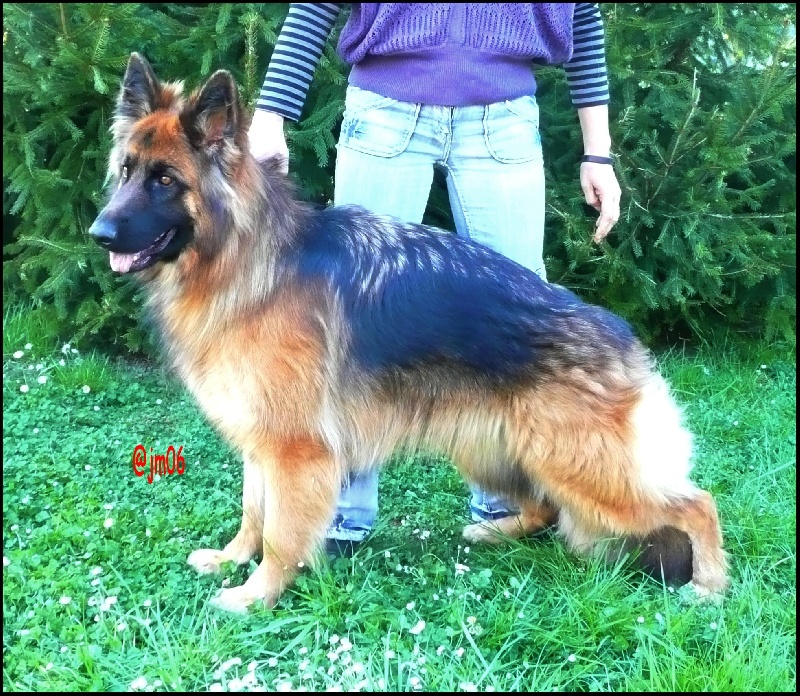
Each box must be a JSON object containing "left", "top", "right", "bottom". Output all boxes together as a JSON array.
[{"left": 527, "top": 375, "right": 728, "bottom": 596}]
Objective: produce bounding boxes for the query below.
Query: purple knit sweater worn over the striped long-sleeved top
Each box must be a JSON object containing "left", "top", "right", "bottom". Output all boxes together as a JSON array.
[{"left": 339, "top": 3, "right": 575, "bottom": 106}]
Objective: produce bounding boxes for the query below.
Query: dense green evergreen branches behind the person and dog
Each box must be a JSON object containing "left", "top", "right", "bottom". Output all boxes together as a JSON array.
[{"left": 3, "top": 3, "right": 796, "bottom": 348}]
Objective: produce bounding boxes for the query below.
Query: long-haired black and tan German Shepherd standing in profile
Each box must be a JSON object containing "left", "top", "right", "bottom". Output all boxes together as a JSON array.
[{"left": 89, "top": 54, "right": 727, "bottom": 611}]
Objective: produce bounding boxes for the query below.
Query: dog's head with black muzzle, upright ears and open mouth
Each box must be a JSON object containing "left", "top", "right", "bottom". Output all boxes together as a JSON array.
[{"left": 89, "top": 53, "right": 247, "bottom": 273}]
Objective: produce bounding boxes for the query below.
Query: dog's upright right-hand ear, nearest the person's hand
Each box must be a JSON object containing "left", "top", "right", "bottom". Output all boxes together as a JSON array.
[{"left": 181, "top": 70, "right": 242, "bottom": 155}]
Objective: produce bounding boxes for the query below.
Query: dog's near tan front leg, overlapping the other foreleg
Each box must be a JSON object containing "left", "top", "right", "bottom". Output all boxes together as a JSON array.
[{"left": 212, "top": 436, "right": 341, "bottom": 612}]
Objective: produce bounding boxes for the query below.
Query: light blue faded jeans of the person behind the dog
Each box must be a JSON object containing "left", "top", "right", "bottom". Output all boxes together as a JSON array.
[{"left": 328, "top": 85, "right": 545, "bottom": 541}]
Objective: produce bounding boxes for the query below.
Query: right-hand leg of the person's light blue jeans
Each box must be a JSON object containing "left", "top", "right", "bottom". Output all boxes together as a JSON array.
[{"left": 445, "top": 97, "right": 546, "bottom": 522}]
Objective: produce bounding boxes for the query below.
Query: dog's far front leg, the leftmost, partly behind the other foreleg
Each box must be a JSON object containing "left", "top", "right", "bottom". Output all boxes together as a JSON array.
[{"left": 189, "top": 455, "right": 265, "bottom": 573}]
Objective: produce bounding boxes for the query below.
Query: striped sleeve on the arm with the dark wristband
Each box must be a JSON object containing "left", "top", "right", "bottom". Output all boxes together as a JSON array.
[{"left": 564, "top": 2, "right": 609, "bottom": 109}]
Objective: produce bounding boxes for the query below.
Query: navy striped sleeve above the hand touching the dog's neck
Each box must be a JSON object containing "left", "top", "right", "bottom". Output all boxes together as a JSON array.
[{"left": 256, "top": 2, "right": 342, "bottom": 121}]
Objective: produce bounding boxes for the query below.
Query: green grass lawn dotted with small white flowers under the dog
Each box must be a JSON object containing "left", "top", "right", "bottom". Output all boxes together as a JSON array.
[{"left": 3, "top": 311, "right": 796, "bottom": 692}]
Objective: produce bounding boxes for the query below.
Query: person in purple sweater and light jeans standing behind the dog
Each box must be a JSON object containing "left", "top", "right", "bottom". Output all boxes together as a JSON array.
[{"left": 249, "top": 3, "right": 620, "bottom": 553}]
